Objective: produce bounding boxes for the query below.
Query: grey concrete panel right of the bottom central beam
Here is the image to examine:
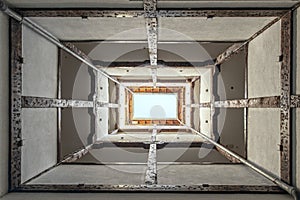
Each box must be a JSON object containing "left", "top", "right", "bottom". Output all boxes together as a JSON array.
[{"left": 157, "top": 164, "right": 274, "bottom": 185}]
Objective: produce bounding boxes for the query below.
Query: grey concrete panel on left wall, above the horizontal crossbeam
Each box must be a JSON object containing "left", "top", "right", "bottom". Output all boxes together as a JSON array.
[{"left": 22, "top": 26, "right": 58, "bottom": 98}]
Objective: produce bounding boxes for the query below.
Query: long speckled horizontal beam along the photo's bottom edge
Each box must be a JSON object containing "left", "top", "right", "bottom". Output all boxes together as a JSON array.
[{"left": 17, "top": 184, "right": 283, "bottom": 193}]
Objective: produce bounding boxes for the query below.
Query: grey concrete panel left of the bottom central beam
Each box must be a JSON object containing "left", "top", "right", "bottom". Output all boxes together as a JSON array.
[{"left": 29, "top": 165, "right": 146, "bottom": 185}]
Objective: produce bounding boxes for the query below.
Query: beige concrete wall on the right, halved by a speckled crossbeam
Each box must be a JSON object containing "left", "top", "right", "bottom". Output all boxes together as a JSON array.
[{"left": 247, "top": 22, "right": 281, "bottom": 175}]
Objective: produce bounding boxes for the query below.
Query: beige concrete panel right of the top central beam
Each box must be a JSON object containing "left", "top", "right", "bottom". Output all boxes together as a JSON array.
[{"left": 159, "top": 17, "right": 273, "bottom": 41}]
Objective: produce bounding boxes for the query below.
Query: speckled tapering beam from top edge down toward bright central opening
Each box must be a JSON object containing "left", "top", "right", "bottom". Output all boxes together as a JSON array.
[{"left": 144, "top": 0, "right": 158, "bottom": 88}]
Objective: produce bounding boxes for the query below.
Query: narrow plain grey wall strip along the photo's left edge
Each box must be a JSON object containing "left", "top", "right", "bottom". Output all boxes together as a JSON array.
[{"left": 0, "top": 13, "right": 9, "bottom": 197}]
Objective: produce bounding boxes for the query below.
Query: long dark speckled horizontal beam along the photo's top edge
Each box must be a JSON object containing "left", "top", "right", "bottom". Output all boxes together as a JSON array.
[{"left": 19, "top": 9, "right": 288, "bottom": 18}]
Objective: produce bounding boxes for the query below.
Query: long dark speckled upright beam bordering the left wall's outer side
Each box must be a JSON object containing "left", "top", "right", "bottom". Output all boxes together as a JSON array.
[{"left": 10, "top": 20, "right": 23, "bottom": 191}]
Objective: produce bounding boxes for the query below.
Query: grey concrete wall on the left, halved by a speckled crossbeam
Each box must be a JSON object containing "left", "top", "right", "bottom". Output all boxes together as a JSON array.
[{"left": 21, "top": 27, "right": 58, "bottom": 181}]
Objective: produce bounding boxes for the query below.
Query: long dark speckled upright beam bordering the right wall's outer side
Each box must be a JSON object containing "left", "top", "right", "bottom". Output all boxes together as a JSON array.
[{"left": 280, "top": 12, "right": 291, "bottom": 183}]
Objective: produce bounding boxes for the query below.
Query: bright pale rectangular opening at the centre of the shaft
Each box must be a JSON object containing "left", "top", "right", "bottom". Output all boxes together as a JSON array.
[{"left": 133, "top": 93, "right": 177, "bottom": 120}]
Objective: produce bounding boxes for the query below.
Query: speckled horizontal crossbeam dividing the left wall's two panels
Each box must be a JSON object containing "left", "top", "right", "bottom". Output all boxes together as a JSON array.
[{"left": 22, "top": 96, "right": 93, "bottom": 108}]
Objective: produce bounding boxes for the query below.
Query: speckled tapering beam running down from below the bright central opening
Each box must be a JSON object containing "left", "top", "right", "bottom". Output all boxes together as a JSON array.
[{"left": 145, "top": 126, "right": 157, "bottom": 185}]
